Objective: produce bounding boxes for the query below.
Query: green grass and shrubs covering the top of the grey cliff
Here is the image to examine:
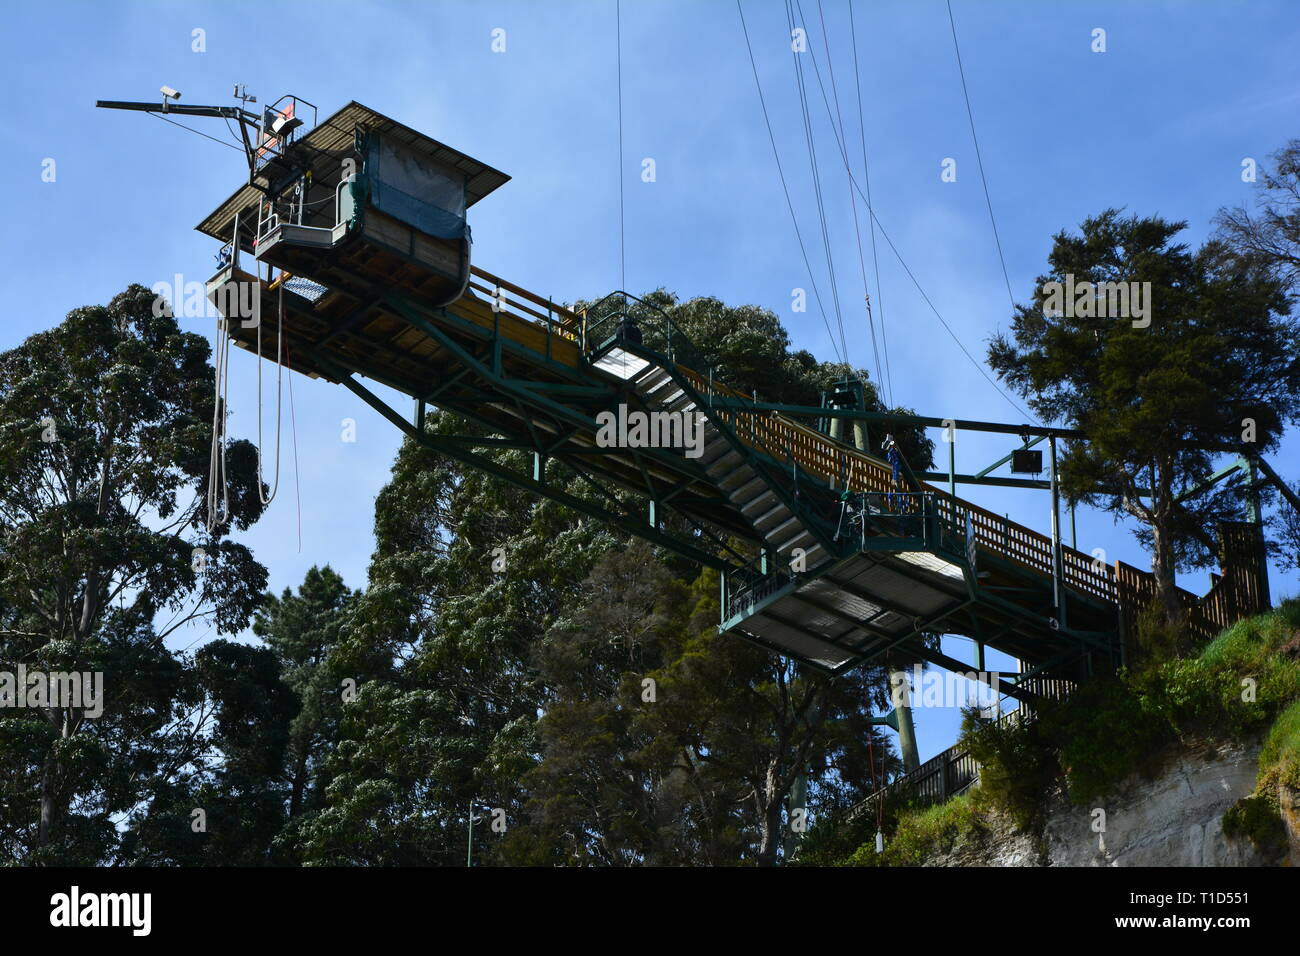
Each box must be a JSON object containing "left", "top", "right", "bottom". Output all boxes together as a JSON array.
[{"left": 845, "top": 598, "right": 1300, "bottom": 866}]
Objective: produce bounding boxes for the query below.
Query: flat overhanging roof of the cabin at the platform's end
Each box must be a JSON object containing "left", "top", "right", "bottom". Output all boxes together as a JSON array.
[{"left": 196, "top": 100, "right": 510, "bottom": 242}]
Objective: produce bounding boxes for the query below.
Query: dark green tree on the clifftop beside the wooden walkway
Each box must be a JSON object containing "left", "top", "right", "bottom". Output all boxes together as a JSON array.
[{"left": 988, "top": 209, "right": 1300, "bottom": 629}]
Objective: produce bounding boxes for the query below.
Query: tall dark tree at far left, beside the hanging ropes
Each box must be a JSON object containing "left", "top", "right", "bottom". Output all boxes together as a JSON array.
[{"left": 0, "top": 285, "right": 269, "bottom": 865}]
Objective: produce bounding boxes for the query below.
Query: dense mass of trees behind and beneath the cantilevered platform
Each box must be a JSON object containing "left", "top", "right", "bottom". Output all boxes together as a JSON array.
[{"left": 286, "top": 293, "right": 904, "bottom": 865}]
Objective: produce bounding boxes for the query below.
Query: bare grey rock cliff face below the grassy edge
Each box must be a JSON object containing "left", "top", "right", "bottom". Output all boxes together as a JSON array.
[{"left": 927, "top": 744, "right": 1300, "bottom": 866}]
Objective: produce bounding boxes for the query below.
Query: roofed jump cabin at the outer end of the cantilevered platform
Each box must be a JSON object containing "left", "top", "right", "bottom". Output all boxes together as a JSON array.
[{"left": 198, "top": 96, "right": 510, "bottom": 371}]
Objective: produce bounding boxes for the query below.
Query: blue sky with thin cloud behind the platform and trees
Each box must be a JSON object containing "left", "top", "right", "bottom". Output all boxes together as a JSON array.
[{"left": 0, "top": 0, "right": 1300, "bottom": 757}]
